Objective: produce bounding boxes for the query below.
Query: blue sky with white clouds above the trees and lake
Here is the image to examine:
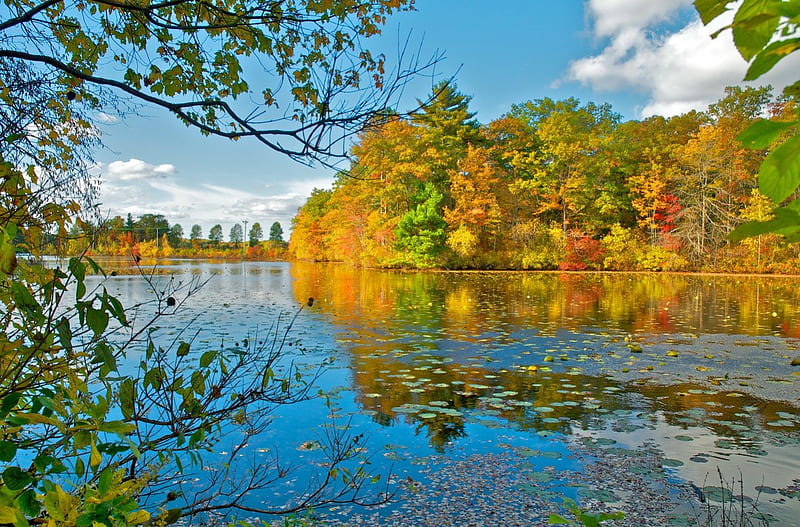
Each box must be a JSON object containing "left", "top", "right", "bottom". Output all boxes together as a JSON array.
[{"left": 90, "top": 0, "right": 800, "bottom": 239}]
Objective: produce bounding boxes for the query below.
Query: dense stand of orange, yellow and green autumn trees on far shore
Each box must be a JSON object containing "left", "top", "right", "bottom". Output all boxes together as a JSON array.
[{"left": 289, "top": 83, "right": 800, "bottom": 272}]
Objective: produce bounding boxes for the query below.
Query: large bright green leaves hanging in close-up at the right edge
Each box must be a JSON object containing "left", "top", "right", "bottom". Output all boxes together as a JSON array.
[{"left": 694, "top": 0, "right": 800, "bottom": 241}]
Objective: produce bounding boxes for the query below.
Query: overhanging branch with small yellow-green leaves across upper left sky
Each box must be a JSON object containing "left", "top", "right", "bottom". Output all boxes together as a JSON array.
[{"left": 0, "top": 0, "right": 435, "bottom": 160}]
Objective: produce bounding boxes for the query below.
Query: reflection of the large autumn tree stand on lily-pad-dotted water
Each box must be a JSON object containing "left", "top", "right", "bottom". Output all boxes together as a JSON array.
[{"left": 291, "top": 264, "right": 800, "bottom": 517}]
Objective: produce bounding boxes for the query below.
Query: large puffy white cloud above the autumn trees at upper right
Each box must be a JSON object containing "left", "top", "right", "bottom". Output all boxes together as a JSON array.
[{"left": 567, "top": 0, "right": 800, "bottom": 117}]
